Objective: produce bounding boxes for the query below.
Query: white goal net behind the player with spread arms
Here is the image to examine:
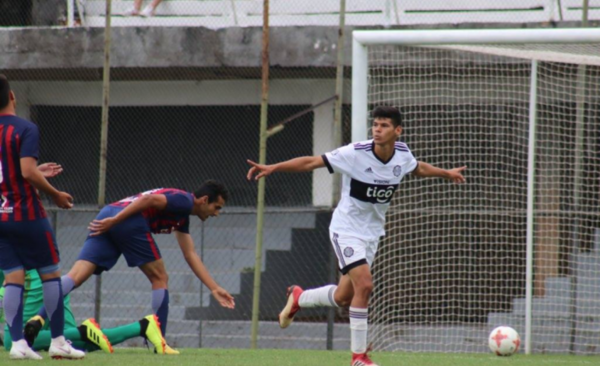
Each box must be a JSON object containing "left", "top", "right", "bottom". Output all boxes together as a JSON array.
[{"left": 353, "top": 31, "right": 600, "bottom": 354}]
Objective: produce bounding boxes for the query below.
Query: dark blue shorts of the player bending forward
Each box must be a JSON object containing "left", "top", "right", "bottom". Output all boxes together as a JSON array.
[{"left": 77, "top": 206, "right": 161, "bottom": 274}]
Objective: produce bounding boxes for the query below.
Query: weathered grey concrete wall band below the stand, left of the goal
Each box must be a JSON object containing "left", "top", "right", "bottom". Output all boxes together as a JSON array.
[{"left": 0, "top": 27, "right": 350, "bottom": 71}]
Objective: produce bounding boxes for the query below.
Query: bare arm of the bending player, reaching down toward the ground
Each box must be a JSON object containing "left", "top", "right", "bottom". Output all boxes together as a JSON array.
[{"left": 175, "top": 231, "right": 235, "bottom": 309}]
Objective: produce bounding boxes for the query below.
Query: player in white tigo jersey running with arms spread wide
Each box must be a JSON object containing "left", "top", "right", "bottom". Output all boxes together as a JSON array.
[{"left": 247, "top": 107, "right": 466, "bottom": 366}]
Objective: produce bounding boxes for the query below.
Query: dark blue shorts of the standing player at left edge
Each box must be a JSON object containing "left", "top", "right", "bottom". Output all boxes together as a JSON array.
[{"left": 0, "top": 218, "right": 60, "bottom": 274}]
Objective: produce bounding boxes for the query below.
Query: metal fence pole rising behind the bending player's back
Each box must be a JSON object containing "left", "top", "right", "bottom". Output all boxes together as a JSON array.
[{"left": 94, "top": 0, "right": 112, "bottom": 321}]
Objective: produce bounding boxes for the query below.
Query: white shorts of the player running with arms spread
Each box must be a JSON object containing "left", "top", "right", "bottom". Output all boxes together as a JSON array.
[{"left": 329, "top": 231, "right": 379, "bottom": 274}]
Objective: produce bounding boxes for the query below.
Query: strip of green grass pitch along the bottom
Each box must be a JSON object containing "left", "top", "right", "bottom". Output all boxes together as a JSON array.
[{"left": 0, "top": 348, "right": 600, "bottom": 366}]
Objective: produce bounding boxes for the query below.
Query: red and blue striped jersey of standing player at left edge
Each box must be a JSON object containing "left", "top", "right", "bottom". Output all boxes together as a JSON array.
[{"left": 0, "top": 114, "right": 46, "bottom": 222}]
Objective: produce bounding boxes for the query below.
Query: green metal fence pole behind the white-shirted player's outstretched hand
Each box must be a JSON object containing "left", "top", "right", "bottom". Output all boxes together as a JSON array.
[{"left": 251, "top": 0, "right": 269, "bottom": 349}]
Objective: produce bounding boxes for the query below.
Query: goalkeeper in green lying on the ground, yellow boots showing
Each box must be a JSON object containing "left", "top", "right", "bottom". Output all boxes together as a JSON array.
[{"left": 0, "top": 270, "right": 176, "bottom": 354}]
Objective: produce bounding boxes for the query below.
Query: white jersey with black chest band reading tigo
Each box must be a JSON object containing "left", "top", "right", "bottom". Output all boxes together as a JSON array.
[{"left": 322, "top": 140, "right": 417, "bottom": 240}]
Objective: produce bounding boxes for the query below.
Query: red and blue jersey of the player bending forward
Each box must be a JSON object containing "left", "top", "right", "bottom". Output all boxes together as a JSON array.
[{"left": 111, "top": 188, "right": 194, "bottom": 234}]
